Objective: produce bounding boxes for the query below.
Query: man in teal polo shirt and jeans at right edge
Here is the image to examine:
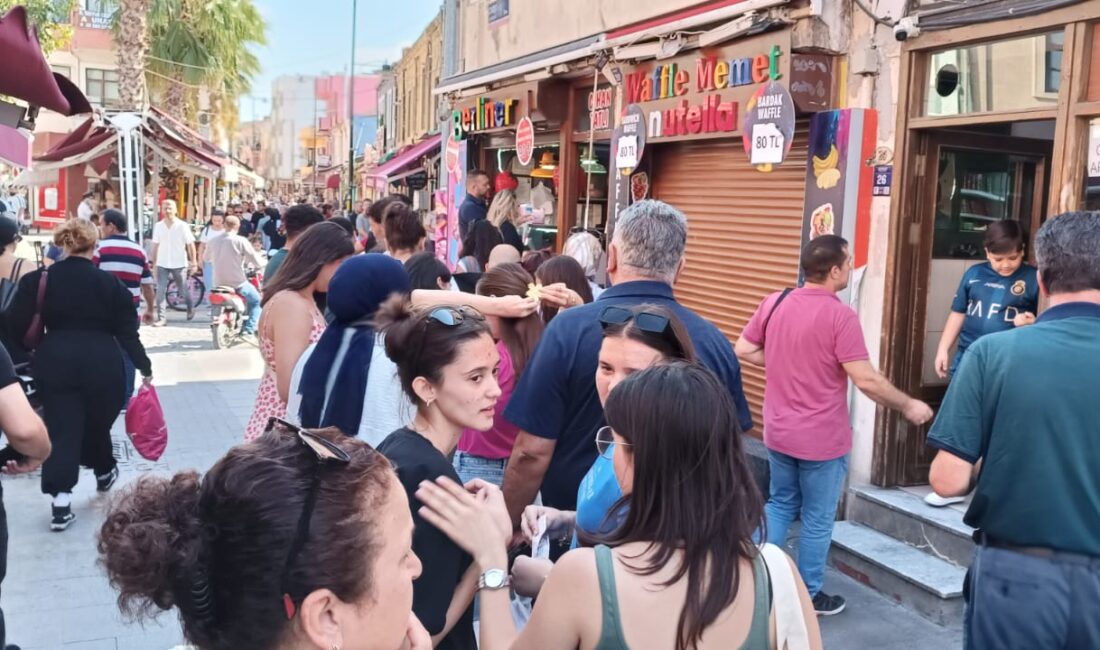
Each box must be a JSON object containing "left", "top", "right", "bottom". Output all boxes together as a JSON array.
[{"left": 928, "top": 212, "right": 1100, "bottom": 650}]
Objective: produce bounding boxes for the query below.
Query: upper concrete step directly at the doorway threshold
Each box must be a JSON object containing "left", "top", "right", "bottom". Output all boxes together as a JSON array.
[{"left": 847, "top": 485, "right": 974, "bottom": 566}]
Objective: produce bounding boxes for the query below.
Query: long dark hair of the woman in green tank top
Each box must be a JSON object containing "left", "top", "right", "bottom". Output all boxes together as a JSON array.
[{"left": 602, "top": 362, "right": 763, "bottom": 650}]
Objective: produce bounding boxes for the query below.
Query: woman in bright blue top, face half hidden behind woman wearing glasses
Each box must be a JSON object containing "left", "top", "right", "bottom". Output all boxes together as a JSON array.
[{"left": 513, "top": 305, "right": 696, "bottom": 596}]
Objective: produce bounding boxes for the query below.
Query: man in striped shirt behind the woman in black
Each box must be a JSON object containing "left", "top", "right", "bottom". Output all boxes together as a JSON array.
[{"left": 96, "top": 210, "right": 156, "bottom": 404}]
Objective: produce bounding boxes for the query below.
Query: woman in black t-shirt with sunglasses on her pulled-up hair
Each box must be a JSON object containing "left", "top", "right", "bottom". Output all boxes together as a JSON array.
[{"left": 375, "top": 297, "right": 501, "bottom": 650}]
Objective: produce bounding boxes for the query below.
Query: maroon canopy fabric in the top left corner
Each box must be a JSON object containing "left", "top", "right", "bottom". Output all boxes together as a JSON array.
[{"left": 0, "top": 7, "right": 91, "bottom": 115}]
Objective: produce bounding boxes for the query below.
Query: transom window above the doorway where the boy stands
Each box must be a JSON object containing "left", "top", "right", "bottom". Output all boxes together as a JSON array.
[{"left": 924, "top": 31, "right": 1065, "bottom": 117}]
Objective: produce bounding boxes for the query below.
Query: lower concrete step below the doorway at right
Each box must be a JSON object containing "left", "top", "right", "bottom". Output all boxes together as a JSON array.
[{"left": 829, "top": 521, "right": 966, "bottom": 626}]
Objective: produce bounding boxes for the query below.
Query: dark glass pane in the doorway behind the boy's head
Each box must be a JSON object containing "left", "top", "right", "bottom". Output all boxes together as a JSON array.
[{"left": 933, "top": 147, "right": 1036, "bottom": 260}]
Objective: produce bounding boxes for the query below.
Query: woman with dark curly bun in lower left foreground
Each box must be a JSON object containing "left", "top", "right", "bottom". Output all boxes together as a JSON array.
[{"left": 98, "top": 419, "right": 431, "bottom": 650}]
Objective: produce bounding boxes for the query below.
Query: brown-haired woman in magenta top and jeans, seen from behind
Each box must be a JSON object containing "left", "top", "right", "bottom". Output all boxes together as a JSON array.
[{"left": 454, "top": 263, "right": 543, "bottom": 486}]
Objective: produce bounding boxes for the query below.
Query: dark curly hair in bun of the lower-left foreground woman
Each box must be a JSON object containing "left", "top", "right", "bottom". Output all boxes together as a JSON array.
[{"left": 98, "top": 429, "right": 395, "bottom": 650}]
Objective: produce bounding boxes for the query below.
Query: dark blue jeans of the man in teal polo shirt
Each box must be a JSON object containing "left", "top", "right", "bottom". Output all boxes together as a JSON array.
[{"left": 963, "top": 546, "right": 1100, "bottom": 650}]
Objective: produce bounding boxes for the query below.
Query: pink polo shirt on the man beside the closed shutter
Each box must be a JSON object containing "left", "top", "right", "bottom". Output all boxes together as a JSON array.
[{"left": 741, "top": 287, "right": 868, "bottom": 461}]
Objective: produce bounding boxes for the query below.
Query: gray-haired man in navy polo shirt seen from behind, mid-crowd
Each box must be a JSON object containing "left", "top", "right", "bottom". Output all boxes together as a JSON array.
[{"left": 504, "top": 200, "right": 752, "bottom": 534}]
